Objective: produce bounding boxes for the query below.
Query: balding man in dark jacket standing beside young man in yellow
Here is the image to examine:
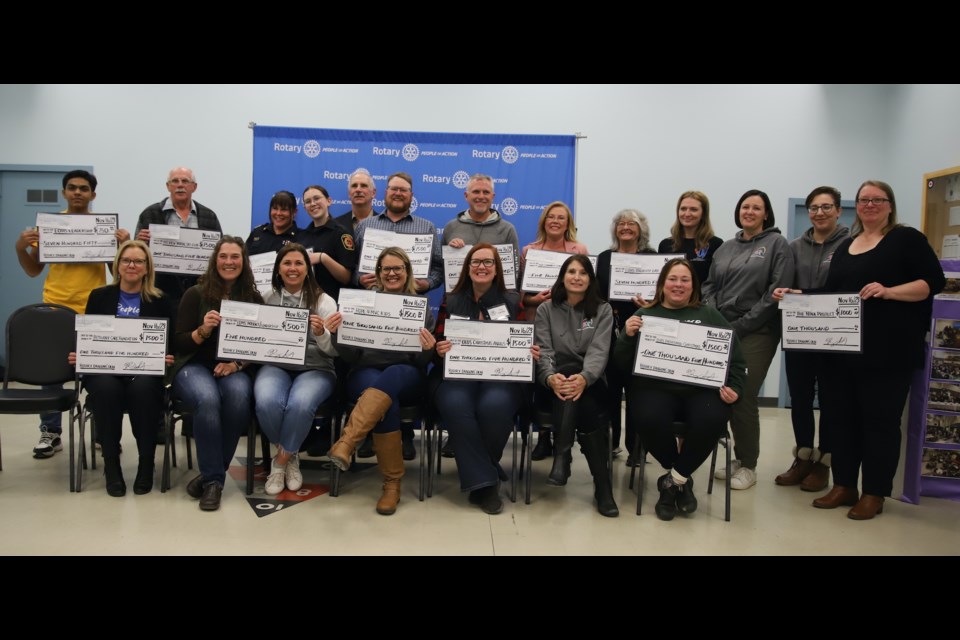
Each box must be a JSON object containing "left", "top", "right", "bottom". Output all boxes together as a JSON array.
[{"left": 137, "top": 167, "right": 223, "bottom": 306}]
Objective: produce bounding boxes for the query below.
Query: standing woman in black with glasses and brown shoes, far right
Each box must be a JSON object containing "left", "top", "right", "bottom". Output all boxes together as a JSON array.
[{"left": 774, "top": 180, "right": 946, "bottom": 520}]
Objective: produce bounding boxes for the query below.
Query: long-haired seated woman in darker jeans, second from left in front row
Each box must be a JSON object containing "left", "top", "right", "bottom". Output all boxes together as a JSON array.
[{"left": 172, "top": 236, "right": 263, "bottom": 511}]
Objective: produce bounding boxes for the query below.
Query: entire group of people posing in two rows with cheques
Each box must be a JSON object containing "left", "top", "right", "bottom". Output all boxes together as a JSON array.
[{"left": 17, "top": 168, "right": 944, "bottom": 520}]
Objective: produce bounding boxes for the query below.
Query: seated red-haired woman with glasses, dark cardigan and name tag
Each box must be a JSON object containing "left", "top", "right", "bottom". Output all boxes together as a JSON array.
[{"left": 434, "top": 243, "right": 539, "bottom": 514}]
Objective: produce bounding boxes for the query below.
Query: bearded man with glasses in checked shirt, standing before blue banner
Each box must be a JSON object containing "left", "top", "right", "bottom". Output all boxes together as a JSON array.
[{"left": 355, "top": 172, "right": 443, "bottom": 294}]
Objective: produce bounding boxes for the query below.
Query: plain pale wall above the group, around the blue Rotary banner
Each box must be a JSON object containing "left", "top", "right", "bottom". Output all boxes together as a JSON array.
[{"left": 0, "top": 85, "right": 960, "bottom": 395}]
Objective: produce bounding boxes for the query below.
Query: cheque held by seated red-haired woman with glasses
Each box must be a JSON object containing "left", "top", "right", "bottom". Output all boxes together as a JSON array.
[{"left": 443, "top": 319, "right": 533, "bottom": 382}]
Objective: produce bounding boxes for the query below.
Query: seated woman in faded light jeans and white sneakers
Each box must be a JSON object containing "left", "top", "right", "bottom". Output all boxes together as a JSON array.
[{"left": 253, "top": 242, "right": 337, "bottom": 496}]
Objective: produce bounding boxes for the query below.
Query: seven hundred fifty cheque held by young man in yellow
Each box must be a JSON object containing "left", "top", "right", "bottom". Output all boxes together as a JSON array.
[{"left": 37, "top": 213, "right": 118, "bottom": 263}]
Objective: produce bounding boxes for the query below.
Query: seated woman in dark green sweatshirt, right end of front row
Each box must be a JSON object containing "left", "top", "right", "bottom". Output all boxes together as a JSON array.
[{"left": 613, "top": 258, "right": 747, "bottom": 520}]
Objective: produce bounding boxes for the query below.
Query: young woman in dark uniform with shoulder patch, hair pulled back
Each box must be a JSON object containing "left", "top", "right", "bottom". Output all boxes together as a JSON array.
[{"left": 297, "top": 184, "right": 357, "bottom": 300}]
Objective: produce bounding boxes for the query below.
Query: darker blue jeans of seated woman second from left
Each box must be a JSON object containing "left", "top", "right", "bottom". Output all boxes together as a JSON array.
[{"left": 173, "top": 364, "right": 253, "bottom": 487}]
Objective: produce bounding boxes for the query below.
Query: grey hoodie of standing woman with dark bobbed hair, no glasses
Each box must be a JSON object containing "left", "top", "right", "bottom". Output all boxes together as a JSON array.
[{"left": 703, "top": 227, "right": 794, "bottom": 338}]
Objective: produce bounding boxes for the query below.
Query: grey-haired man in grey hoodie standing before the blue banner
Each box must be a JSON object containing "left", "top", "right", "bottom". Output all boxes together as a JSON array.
[{"left": 443, "top": 173, "right": 520, "bottom": 264}]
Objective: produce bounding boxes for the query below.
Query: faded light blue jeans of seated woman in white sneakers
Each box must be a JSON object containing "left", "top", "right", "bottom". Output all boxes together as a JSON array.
[{"left": 253, "top": 364, "right": 337, "bottom": 453}]
